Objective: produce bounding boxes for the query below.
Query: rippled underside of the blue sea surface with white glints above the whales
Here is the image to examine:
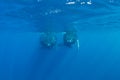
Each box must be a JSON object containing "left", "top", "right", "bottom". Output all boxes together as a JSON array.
[{"left": 0, "top": 0, "right": 120, "bottom": 31}]
